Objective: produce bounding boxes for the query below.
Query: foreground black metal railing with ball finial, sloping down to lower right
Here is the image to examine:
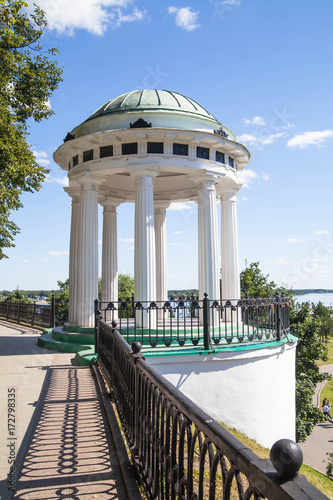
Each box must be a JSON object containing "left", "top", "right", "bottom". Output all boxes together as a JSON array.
[{"left": 96, "top": 314, "right": 327, "bottom": 500}]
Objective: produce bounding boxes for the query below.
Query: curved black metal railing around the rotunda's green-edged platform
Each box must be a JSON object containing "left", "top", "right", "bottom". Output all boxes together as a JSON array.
[{"left": 96, "top": 295, "right": 290, "bottom": 350}]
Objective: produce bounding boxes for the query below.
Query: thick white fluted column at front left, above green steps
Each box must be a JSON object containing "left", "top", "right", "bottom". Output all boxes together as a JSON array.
[{"left": 77, "top": 174, "right": 98, "bottom": 328}]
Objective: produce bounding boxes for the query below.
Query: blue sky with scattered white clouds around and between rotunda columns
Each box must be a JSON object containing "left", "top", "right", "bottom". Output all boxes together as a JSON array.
[{"left": 0, "top": 0, "right": 333, "bottom": 290}]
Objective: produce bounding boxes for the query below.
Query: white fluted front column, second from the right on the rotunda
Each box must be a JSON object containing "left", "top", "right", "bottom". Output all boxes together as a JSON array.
[{"left": 198, "top": 175, "right": 219, "bottom": 300}]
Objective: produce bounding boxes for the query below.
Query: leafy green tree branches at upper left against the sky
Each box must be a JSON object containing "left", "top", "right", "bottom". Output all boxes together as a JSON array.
[{"left": 0, "top": 0, "right": 62, "bottom": 259}]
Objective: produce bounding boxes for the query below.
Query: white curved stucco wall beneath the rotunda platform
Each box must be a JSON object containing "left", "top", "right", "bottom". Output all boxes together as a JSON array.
[{"left": 146, "top": 342, "right": 296, "bottom": 448}]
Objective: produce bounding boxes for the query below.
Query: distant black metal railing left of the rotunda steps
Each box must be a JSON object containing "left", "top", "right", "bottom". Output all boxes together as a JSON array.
[{"left": 0, "top": 296, "right": 55, "bottom": 328}]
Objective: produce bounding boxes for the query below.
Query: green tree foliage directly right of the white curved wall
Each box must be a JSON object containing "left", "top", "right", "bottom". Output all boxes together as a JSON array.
[{"left": 290, "top": 303, "right": 330, "bottom": 441}]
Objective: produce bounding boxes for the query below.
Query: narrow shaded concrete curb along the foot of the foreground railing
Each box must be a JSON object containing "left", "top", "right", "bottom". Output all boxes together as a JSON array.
[{"left": 91, "top": 365, "right": 142, "bottom": 500}]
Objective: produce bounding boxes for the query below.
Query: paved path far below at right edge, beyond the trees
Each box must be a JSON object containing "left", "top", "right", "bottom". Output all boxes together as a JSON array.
[{"left": 300, "top": 365, "right": 333, "bottom": 474}]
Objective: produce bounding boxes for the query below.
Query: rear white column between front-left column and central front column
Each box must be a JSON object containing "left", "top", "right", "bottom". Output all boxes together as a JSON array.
[{"left": 101, "top": 198, "right": 120, "bottom": 319}]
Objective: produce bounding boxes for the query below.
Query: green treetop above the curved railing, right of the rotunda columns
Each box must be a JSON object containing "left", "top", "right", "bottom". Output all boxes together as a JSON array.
[{"left": 240, "top": 260, "right": 285, "bottom": 297}]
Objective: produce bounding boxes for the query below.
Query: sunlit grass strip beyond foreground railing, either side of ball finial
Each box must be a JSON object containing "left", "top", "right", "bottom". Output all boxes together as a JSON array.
[{"left": 220, "top": 422, "right": 333, "bottom": 500}]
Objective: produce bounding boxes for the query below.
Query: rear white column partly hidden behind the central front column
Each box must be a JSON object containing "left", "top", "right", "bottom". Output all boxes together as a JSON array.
[{"left": 154, "top": 202, "right": 170, "bottom": 306}]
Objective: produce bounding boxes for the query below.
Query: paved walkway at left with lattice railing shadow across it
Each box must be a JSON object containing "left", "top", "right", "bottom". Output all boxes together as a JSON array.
[{"left": 0, "top": 320, "right": 137, "bottom": 500}]
